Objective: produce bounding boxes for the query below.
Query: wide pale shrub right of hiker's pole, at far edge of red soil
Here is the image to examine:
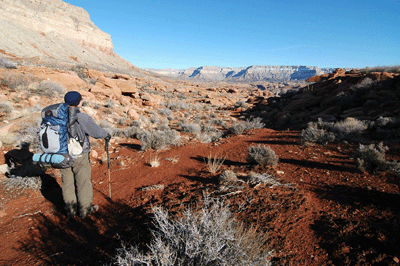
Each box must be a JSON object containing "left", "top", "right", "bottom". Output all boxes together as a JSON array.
[{"left": 138, "top": 129, "right": 179, "bottom": 150}]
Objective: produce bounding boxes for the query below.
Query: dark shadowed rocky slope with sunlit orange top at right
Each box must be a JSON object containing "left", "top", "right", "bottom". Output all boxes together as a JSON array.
[{"left": 250, "top": 68, "right": 400, "bottom": 129}]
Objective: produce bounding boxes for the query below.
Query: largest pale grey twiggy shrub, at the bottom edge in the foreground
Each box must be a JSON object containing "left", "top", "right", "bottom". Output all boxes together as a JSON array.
[{"left": 114, "top": 197, "right": 273, "bottom": 266}]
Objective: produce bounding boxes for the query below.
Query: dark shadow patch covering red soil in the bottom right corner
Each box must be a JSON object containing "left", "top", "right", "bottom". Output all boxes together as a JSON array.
[{"left": 312, "top": 185, "right": 400, "bottom": 265}]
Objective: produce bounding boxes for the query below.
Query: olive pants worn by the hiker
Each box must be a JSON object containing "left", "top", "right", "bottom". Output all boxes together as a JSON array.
[{"left": 61, "top": 153, "right": 93, "bottom": 218}]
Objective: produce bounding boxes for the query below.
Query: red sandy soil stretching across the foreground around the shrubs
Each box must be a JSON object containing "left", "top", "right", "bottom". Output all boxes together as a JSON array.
[{"left": 0, "top": 129, "right": 400, "bottom": 265}]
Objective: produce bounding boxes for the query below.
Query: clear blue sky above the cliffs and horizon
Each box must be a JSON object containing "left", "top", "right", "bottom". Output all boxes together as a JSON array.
[{"left": 65, "top": 0, "right": 400, "bottom": 69}]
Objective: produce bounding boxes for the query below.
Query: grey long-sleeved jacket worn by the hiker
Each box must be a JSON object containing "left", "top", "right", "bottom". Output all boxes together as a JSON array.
[{"left": 76, "top": 112, "right": 109, "bottom": 153}]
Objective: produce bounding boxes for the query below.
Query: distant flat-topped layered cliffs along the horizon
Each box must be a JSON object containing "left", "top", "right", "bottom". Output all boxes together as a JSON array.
[{"left": 148, "top": 66, "right": 334, "bottom": 81}]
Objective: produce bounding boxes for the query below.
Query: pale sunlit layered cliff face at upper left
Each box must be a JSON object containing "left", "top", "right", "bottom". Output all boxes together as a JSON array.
[{"left": 0, "top": 0, "right": 131, "bottom": 71}]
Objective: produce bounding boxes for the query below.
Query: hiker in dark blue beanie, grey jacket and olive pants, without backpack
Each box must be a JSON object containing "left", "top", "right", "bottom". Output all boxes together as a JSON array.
[{"left": 60, "top": 91, "right": 111, "bottom": 218}]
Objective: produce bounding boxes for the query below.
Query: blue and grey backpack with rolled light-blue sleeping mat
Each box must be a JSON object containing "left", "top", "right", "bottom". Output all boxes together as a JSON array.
[{"left": 33, "top": 103, "right": 82, "bottom": 169}]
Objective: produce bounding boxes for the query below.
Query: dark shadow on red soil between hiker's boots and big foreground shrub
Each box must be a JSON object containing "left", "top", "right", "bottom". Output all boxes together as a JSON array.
[{"left": 20, "top": 196, "right": 151, "bottom": 265}]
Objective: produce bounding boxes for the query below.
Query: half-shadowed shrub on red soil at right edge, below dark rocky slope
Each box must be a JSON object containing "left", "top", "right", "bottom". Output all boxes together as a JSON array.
[{"left": 353, "top": 142, "right": 400, "bottom": 173}]
